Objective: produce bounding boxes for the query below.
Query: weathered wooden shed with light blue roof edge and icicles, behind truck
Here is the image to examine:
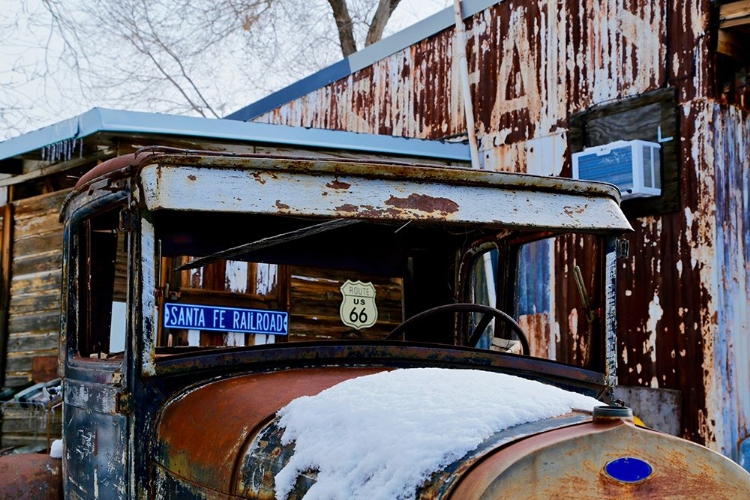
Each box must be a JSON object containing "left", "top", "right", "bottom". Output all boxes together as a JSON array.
[{"left": 0, "top": 109, "right": 469, "bottom": 448}]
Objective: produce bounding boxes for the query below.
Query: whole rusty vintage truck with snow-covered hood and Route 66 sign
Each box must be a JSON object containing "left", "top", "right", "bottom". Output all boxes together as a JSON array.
[{"left": 38, "top": 147, "right": 750, "bottom": 499}]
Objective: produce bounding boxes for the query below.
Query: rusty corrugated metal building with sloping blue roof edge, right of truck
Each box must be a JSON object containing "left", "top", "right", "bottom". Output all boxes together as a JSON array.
[{"left": 228, "top": 0, "right": 750, "bottom": 469}]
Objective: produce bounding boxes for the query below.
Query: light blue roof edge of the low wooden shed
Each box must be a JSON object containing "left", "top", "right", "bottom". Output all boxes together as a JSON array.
[{"left": 0, "top": 108, "right": 470, "bottom": 161}]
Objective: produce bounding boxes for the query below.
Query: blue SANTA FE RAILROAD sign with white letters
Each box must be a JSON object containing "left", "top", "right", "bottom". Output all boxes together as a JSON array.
[{"left": 164, "top": 302, "right": 289, "bottom": 335}]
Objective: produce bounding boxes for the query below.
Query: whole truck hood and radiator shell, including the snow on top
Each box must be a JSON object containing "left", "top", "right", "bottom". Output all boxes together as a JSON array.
[{"left": 153, "top": 367, "right": 750, "bottom": 500}]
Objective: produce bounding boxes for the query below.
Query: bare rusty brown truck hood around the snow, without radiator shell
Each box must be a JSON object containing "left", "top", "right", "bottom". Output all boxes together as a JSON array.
[{"left": 154, "top": 367, "right": 590, "bottom": 499}]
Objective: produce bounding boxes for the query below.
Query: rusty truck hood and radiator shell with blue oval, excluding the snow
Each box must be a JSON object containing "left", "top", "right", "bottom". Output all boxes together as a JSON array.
[{"left": 154, "top": 367, "right": 750, "bottom": 500}]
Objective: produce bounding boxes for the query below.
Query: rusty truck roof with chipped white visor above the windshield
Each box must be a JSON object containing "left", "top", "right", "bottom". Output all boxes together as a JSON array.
[{"left": 66, "top": 150, "right": 632, "bottom": 232}]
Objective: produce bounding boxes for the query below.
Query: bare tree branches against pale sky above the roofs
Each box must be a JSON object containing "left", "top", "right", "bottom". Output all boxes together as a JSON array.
[{"left": 0, "top": 0, "right": 447, "bottom": 136}]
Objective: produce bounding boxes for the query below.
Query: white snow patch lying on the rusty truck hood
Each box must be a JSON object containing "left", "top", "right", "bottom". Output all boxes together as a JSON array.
[{"left": 275, "top": 368, "right": 601, "bottom": 500}]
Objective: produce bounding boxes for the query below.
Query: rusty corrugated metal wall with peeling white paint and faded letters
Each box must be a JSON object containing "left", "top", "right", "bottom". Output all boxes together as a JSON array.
[{"left": 255, "top": 0, "right": 750, "bottom": 458}]
